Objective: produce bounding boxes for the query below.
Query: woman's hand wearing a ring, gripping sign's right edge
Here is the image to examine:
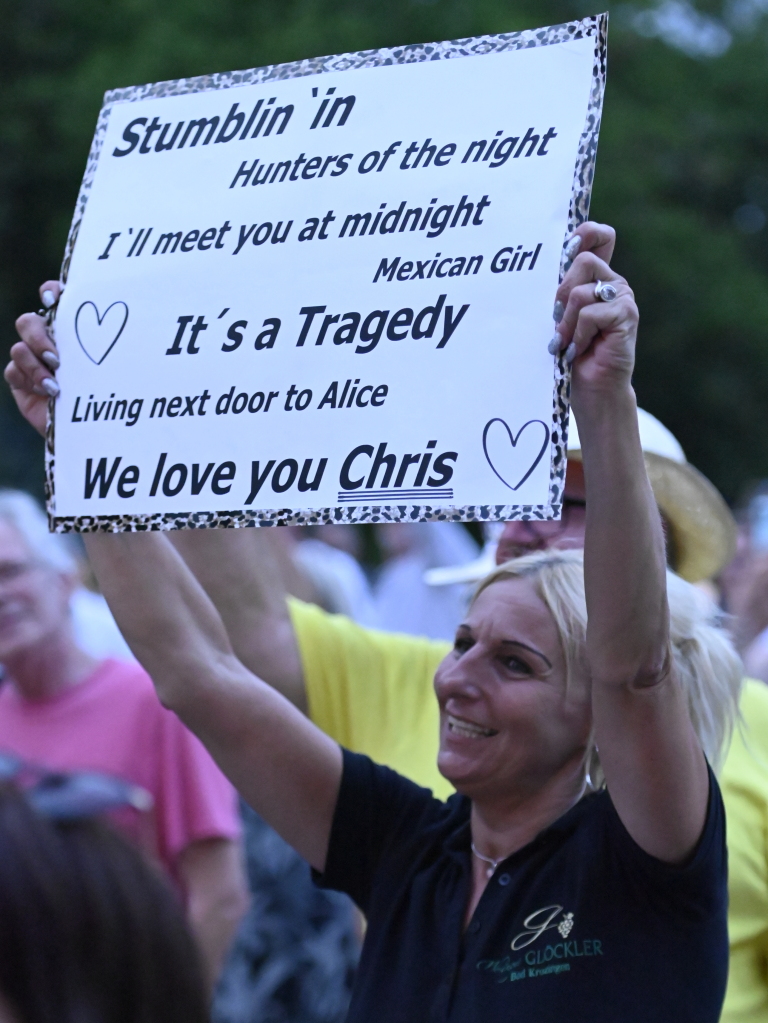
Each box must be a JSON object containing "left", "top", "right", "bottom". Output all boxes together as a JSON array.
[{"left": 551, "top": 221, "right": 638, "bottom": 396}]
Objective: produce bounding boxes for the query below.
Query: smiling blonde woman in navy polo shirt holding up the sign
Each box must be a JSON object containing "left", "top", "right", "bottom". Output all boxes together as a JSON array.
[{"left": 6, "top": 225, "right": 740, "bottom": 1023}]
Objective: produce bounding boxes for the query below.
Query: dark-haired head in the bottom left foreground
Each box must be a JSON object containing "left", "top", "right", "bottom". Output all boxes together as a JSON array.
[{"left": 0, "top": 784, "right": 208, "bottom": 1023}]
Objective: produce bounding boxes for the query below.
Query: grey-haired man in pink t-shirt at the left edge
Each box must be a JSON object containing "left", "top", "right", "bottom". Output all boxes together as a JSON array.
[{"left": 0, "top": 491, "right": 247, "bottom": 985}]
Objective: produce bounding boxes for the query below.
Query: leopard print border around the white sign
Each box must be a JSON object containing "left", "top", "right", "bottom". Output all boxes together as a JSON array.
[{"left": 46, "top": 14, "right": 607, "bottom": 533}]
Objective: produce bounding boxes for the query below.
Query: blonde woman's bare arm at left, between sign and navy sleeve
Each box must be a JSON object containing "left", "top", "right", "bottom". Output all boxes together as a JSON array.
[{"left": 85, "top": 532, "right": 342, "bottom": 871}]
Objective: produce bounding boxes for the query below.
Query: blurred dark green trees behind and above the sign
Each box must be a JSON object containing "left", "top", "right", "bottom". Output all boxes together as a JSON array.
[{"left": 0, "top": 0, "right": 768, "bottom": 500}]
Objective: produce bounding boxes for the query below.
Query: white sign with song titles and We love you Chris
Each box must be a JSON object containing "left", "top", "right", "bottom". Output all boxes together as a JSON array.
[{"left": 48, "top": 15, "right": 606, "bottom": 530}]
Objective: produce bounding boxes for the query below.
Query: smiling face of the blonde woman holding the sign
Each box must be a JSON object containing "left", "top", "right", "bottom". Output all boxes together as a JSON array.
[{"left": 435, "top": 578, "right": 591, "bottom": 799}]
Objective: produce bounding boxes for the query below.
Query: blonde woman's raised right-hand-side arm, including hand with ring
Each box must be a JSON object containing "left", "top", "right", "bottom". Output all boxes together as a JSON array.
[{"left": 557, "top": 224, "right": 709, "bottom": 862}]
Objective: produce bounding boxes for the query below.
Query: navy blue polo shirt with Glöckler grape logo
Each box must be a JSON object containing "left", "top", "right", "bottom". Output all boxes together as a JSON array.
[{"left": 316, "top": 751, "right": 728, "bottom": 1023}]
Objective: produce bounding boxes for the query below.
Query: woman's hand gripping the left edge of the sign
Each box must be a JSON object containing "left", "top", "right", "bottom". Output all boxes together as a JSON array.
[{"left": 5, "top": 280, "right": 62, "bottom": 436}]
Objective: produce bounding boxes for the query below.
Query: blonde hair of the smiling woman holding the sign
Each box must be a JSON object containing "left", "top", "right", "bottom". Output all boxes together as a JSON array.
[{"left": 472, "top": 550, "right": 743, "bottom": 787}]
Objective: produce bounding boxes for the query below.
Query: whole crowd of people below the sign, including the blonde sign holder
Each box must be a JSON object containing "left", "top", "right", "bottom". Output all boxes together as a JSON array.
[{"left": 0, "top": 223, "right": 768, "bottom": 1023}]
